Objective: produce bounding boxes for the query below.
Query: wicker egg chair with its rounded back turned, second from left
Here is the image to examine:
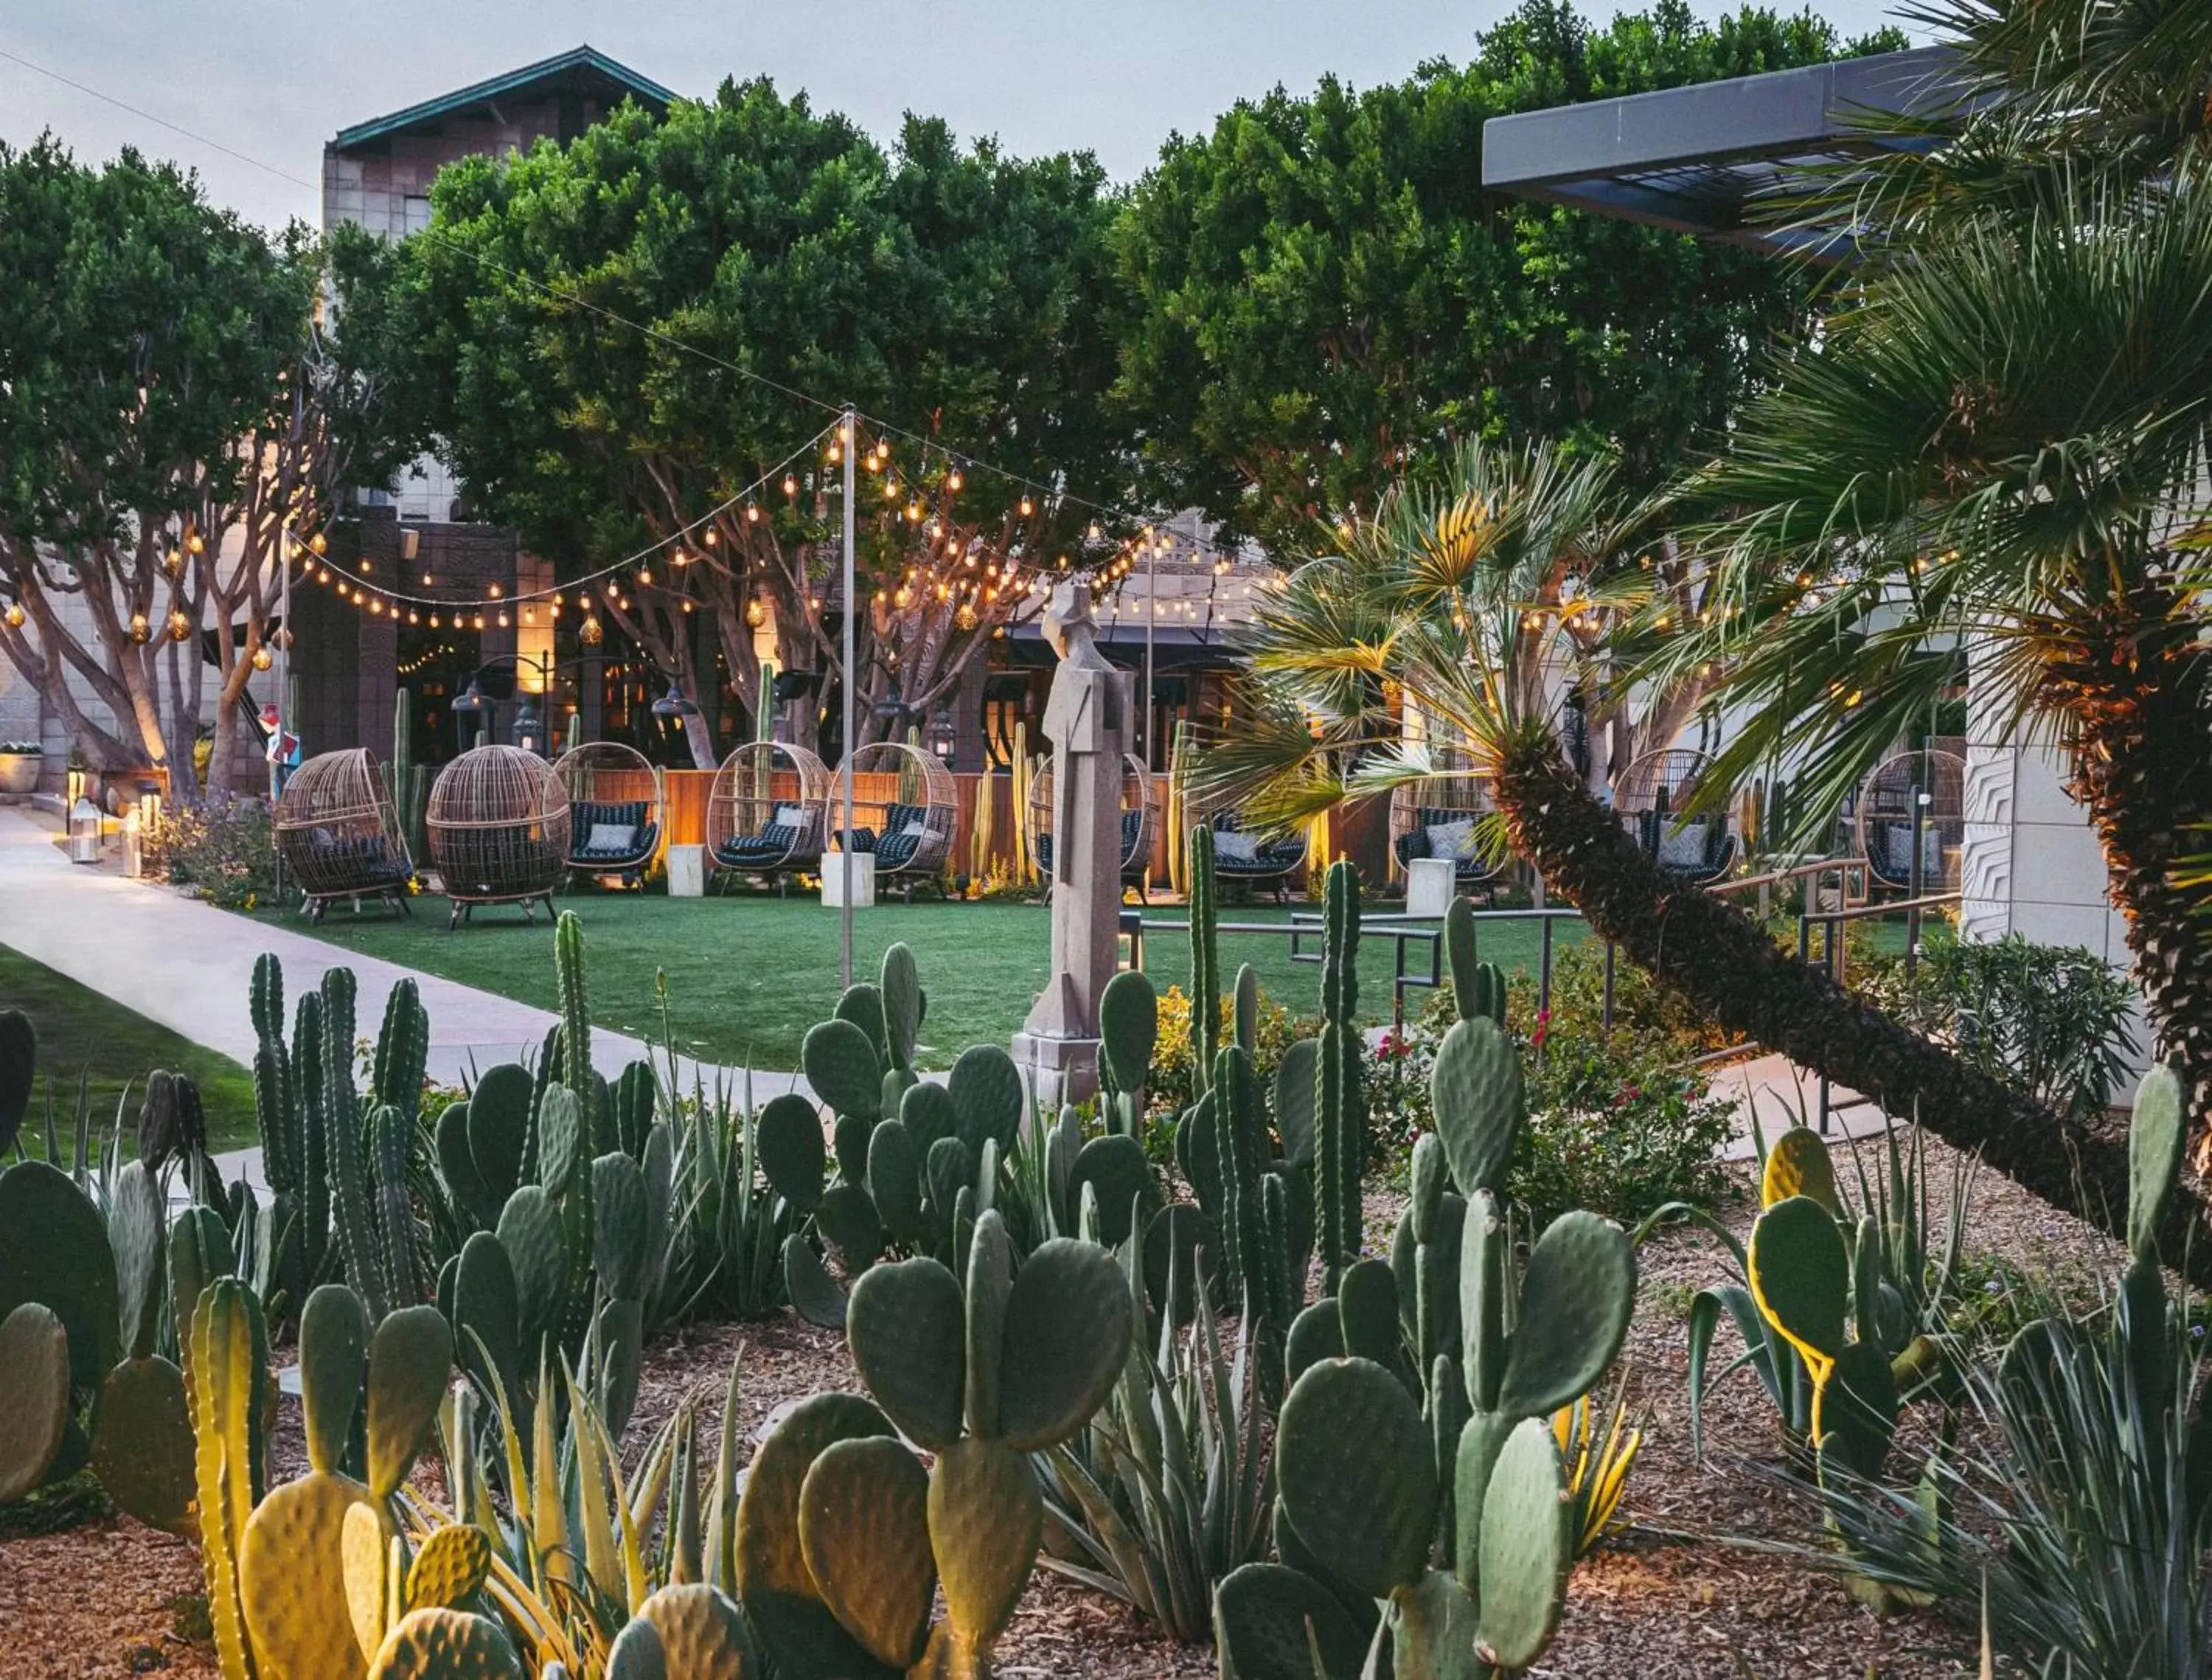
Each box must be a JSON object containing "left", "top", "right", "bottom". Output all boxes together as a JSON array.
[{"left": 427, "top": 746, "right": 571, "bottom": 928}]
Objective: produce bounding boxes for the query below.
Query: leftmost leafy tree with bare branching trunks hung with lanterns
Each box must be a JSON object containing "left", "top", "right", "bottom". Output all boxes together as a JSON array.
[{"left": 0, "top": 137, "right": 392, "bottom": 801}]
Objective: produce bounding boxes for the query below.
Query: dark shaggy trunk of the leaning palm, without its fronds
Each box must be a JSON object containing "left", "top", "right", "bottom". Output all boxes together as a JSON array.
[{"left": 1495, "top": 741, "right": 2212, "bottom": 1284}]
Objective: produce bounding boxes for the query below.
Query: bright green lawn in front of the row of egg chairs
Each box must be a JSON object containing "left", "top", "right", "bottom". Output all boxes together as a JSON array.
[{"left": 237, "top": 895, "right": 1579, "bottom": 1069}]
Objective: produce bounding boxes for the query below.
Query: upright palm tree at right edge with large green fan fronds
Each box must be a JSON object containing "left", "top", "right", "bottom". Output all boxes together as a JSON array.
[{"left": 1639, "top": 164, "right": 2212, "bottom": 1159}]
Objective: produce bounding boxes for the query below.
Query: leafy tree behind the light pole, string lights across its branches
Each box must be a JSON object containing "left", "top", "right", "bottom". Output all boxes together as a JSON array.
[{"left": 383, "top": 80, "right": 1126, "bottom": 757}]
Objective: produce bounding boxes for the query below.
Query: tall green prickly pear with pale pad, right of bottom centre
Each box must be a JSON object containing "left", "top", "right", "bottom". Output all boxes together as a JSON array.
[{"left": 1214, "top": 978, "right": 1635, "bottom": 1680}]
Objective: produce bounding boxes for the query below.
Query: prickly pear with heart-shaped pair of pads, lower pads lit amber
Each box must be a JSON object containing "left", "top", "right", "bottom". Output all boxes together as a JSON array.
[{"left": 737, "top": 1212, "right": 1135, "bottom": 1678}]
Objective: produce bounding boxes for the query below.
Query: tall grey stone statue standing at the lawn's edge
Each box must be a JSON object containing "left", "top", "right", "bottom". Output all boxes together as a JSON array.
[{"left": 1013, "top": 582, "right": 1133, "bottom": 1107}]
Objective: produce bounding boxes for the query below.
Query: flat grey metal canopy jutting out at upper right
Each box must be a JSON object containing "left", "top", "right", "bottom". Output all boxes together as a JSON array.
[{"left": 1482, "top": 46, "right": 1955, "bottom": 257}]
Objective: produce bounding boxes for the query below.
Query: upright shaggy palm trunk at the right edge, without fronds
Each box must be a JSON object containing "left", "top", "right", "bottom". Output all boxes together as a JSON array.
[{"left": 2046, "top": 597, "right": 2212, "bottom": 1173}]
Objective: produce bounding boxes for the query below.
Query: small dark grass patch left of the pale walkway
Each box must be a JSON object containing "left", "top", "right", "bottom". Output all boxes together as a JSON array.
[{"left": 0, "top": 945, "right": 259, "bottom": 1149}]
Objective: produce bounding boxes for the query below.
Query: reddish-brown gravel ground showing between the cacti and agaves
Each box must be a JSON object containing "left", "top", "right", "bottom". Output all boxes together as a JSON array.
[{"left": 13, "top": 1128, "right": 2112, "bottom": 1680}]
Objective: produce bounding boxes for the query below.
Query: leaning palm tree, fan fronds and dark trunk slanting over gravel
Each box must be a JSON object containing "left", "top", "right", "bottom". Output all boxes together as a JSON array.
[{"left": 1197, "top": 445, "right": 2212, "bottom": 1277}]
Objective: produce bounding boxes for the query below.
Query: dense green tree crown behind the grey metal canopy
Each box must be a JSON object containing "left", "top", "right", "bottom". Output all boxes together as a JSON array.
[{"left": 1115, "top": 0, "right": 1902, "bottom": 553}]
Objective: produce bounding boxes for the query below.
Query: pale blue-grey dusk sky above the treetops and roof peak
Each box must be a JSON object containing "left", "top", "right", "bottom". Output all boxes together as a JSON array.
[{"left": 0, "top": 0, "right": 1920, "bottom": 223}]
